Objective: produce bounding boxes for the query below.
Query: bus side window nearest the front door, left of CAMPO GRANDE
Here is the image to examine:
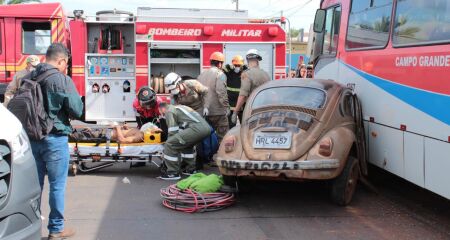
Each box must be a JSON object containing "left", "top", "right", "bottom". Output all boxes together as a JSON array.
[{"left": 345, "top": 0, "right": 392, "bottom": 50}]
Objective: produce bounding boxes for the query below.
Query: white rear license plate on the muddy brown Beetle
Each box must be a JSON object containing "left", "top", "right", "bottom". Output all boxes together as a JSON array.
[{"left": 253, "top": 132, "right": 292, "bottom": 149}]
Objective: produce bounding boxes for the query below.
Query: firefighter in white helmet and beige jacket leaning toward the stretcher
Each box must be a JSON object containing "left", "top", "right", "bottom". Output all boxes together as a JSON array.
[{"left": 164, "top": 72, "right": 208, "bottom": 115}]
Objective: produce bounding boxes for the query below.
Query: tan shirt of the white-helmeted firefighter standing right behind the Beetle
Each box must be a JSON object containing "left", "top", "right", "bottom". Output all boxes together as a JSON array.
[{"left": 239, "top": 66, "right": 270, "bottom": 97}]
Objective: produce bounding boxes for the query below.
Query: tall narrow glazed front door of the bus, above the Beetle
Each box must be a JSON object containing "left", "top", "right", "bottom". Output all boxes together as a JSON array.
[{"left": 311, "top": 4, "right": 342, "bottom": 79}]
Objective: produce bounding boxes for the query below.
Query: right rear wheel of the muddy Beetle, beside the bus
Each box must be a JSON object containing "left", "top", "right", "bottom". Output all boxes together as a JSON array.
[{"left": 331, "top": 156, "right": 359, "bottom": 206}]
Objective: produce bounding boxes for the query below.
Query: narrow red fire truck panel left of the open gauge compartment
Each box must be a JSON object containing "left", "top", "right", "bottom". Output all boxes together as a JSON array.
[{"left": 69, "top": 21, "right": 88, "bottom": 96}]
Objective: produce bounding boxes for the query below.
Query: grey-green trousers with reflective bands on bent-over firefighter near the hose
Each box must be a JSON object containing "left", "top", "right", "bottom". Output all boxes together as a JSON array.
[{"left": 163, "top": 123, "right": 211, "bottom": 174}]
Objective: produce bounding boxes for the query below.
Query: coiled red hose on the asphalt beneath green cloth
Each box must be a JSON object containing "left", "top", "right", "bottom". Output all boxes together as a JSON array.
[{"left": 160, "top": 184, "right": 235, "bottom": 213}]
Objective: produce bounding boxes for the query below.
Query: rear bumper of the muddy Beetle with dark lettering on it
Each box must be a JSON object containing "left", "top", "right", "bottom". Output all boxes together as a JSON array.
[{"left": 216, "top": 158, "right": 342, "bottom": 180}]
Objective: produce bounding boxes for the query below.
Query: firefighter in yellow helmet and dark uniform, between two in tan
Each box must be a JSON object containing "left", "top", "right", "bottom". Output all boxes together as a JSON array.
[{"left": 223, "top": 55, "right": 247, "bottom": 128}]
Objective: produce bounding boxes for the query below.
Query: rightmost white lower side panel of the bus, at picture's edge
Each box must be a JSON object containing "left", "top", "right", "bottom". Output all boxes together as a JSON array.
[{"left": 425, "top": 138, "right": 450, "bottom": 199}]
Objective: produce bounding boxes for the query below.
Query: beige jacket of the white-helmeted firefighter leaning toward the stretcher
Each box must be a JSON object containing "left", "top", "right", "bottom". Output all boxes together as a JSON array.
[{"left": 174, "top": 79, "right": 208, "bottom": 115}]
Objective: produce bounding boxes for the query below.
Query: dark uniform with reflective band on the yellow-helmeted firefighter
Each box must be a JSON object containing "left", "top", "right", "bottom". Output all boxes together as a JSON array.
[{"left": 223, "top": 64, "right": 247, "bottom": 128}]
